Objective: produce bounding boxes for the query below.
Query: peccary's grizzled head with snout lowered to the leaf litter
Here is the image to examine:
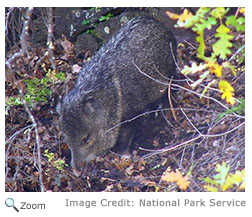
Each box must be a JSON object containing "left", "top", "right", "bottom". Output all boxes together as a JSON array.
[{"left": 58, "top": 87, "right": 119, "bottom": 171}]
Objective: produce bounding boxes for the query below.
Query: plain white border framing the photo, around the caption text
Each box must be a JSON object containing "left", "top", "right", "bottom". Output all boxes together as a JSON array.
[{"left": 0, "top": 0, "right": 252, "bottom": 217}]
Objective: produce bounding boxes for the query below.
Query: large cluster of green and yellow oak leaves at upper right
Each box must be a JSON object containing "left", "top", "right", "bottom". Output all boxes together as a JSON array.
[{"left": 167, "top": 7, "right": 245, "bottom": 104}]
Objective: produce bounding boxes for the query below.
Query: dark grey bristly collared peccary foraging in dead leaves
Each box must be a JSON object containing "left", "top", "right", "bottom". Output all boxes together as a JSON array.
[{"left": 60, "top": 16, "right": 176, "bottom": 175}]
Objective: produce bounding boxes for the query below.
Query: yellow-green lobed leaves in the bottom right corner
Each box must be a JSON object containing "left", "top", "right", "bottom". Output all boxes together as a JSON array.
[{"left": 203, "top": 162, "right": 245, "bottom": 192}]
